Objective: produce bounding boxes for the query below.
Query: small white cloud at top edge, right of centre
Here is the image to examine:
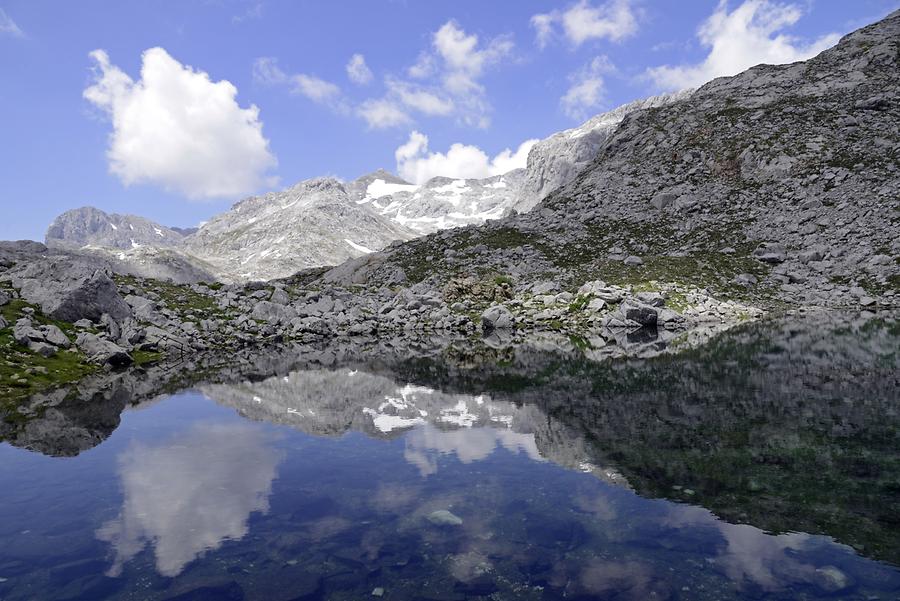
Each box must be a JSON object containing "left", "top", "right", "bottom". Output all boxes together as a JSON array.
[{"left": 531, "top": 0, "right": 638, "bottom": 48}]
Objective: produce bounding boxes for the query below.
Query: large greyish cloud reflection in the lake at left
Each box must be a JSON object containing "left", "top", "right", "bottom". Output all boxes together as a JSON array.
[{"left": 97, "top": 424, "right": 281, "bottom": 577}]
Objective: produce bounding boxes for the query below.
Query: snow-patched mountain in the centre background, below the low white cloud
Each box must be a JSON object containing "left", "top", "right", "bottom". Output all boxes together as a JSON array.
[{"left": 358, "top": 169, "right": 524, "bottom": 235}]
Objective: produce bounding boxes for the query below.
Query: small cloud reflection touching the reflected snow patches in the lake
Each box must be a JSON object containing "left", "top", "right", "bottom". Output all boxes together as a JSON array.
[{"left": 403, "top": 425, "right": 543, "bottom": 476}]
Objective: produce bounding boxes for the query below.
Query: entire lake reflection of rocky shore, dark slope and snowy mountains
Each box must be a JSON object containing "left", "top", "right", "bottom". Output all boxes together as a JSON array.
[{"left": 3, "top": 314, "right": 900, "bottom": 563}]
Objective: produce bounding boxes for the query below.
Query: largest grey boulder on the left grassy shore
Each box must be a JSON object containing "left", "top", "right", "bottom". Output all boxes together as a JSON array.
[{"left": 6, "top": 255, "right": 131, "bottom": 322}]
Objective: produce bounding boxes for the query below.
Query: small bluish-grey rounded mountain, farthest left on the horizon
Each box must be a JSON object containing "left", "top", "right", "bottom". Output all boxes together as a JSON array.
[{"left": 46, "top": 207, "right": 184, "bottom": 249}]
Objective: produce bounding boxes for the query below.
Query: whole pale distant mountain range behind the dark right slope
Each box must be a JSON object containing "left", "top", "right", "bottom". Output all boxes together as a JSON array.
[{"left": 46, "top": 91, "right": 690, "bottom": 283}]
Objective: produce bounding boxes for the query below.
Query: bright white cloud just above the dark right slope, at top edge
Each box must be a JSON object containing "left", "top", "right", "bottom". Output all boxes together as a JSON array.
[{"left": 647, "top": 0, "right": 840, "bottom": 90}]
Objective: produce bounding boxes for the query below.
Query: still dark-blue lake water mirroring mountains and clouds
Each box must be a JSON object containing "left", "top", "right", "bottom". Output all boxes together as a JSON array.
[{"left": 0, "top": 319, "right": 900, "bottom": 601}]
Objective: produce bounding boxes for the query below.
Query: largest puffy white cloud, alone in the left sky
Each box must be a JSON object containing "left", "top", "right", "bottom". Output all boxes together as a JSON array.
[{"left": 84, "top": 48, "right": 277, "bottom": 199}]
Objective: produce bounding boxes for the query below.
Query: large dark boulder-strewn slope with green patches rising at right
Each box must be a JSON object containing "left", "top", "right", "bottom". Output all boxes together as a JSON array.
[{"left": 323, "top": 11, "right": 900, "bottom": 314}]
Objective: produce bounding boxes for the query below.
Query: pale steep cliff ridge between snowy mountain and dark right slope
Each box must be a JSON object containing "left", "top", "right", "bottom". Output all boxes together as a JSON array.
[{"left": 511, "top": 90, "right": 693, "bottom": 213}]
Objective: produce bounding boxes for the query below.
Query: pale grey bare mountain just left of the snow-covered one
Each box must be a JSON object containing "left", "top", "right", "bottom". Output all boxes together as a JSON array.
[{"left": 184, "top": 178, "right": 415, "bottom": 279}]
